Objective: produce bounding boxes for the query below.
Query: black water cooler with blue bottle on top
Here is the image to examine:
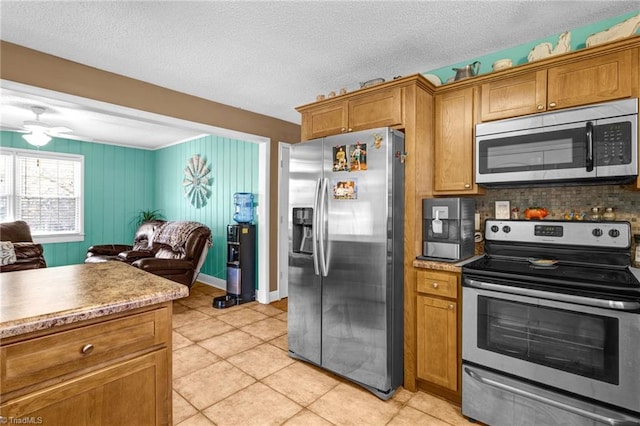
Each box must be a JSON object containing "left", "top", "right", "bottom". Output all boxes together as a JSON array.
[{"left": 213, "top": 193, "right": 257, "bottom": 309}]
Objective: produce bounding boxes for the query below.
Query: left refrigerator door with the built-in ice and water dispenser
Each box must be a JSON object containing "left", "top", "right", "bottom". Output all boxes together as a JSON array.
[{"left": 287, "top": 140, "right": 322, "bottom": 364}]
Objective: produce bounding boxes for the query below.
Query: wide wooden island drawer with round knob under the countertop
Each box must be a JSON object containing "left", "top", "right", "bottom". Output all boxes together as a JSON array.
[{"left": 0, "top": 307, "right": 171, "bottom": 394}]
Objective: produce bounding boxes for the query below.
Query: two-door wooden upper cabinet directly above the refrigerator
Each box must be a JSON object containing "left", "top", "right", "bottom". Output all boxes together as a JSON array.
[{"left": 302, "top": 87, "right": 402, "bottom": 140}]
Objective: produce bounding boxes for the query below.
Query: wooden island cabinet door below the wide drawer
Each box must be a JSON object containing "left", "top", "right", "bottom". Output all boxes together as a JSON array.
[{"left": 0, "top": 349, "right": 171, "bottom": 426}]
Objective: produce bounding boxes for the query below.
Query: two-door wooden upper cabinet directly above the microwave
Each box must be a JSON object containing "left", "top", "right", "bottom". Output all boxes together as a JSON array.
[{"left": 480, "top": 50, "right": 637, "bottom": 121}]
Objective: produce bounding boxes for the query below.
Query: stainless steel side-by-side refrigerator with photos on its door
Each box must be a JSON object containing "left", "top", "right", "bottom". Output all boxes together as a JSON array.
[{"left": 288, "top": 128, "right": 405, "bottom": 399}]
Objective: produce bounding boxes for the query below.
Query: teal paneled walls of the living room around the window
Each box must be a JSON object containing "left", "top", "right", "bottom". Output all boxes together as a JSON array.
[{"left": 0, "top": 131, "right": 259, "bottom": 279}]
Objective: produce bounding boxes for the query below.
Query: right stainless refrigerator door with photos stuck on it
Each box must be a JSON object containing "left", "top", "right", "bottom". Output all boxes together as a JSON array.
[{"left": 322, "top": 128, "right": 403, "bottom": 390}]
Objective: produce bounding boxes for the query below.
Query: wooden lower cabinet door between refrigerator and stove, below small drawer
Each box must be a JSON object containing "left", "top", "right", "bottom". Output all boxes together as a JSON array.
[{"left": 417, "top": 296, "right": 458, "bottom": 392}]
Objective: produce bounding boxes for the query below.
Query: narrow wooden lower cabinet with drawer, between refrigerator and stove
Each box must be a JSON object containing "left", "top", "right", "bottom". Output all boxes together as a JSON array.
[{"left": 416, "top": 270, "right": 462, "bottom": 403}]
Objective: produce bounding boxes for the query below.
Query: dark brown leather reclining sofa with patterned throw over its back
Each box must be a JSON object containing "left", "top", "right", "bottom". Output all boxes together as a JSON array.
[{"left": 85, "top": 220, "right": 211, "bottom": 288}]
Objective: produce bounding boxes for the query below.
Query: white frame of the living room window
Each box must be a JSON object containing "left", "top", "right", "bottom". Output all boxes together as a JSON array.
[{"left": 0, "top": 148, "right": 85, "bottom": 244}]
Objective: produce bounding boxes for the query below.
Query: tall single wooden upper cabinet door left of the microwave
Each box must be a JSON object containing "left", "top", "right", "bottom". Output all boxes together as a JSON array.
[{"left": 433, "top": 88, "right": 477, "bottom": 195}]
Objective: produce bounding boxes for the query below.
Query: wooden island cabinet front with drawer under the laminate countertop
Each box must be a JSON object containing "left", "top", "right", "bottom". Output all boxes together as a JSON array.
[{"left": 0, "top": 302, "right": 172, "bottom": 426}]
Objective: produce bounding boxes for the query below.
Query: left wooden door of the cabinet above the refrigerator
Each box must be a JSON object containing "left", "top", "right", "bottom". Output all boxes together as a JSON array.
[{"left": 302, "top": 101, "right": 349, "bottom": 140}]
